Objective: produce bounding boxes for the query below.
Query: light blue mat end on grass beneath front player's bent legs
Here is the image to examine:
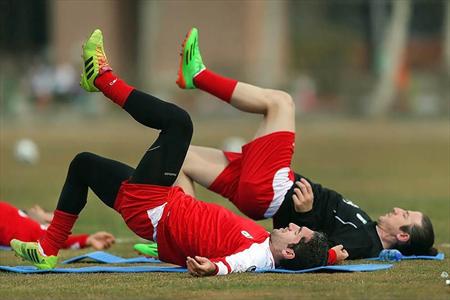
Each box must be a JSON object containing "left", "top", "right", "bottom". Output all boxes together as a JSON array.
[{"left": 62, "top": 251, "right": 161, "bottom": 264}]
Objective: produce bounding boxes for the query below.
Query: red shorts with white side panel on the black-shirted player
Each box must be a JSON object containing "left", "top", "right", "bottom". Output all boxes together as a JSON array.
[{"left": 209, "top": 131, "right": 295, "bottom": 220}]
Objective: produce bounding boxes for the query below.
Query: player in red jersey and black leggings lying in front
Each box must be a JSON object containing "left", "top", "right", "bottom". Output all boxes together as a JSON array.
[{"left": 11, "top": 29, "right": 327, "bottom": 276}]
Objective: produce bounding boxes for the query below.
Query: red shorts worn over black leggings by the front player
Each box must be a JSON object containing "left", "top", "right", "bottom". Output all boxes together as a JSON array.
[{"left": 114, "top": 181, "right": 174, "bottom": 242}]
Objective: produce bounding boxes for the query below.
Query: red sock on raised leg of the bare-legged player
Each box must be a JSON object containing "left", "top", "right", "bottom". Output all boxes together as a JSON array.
[{"left": 194, "top": 69, "right": 238, "bottom": 103}]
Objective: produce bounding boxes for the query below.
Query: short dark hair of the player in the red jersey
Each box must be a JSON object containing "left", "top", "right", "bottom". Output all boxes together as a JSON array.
[{"left": 280, "top": 231, "right": 328, "bottom": 270}]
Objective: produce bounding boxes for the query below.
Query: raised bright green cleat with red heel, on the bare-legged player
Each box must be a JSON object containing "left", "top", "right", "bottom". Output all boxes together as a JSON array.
[{"left": 177, "top": 28, "right": 205, "bottom": 89}]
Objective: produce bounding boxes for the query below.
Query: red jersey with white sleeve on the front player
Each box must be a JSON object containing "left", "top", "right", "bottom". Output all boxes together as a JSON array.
[{"left": 157, "top": 188, "right": 274, "bottom": 274}]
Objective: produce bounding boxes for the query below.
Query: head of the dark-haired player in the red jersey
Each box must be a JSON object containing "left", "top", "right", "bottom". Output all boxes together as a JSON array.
[{"left": 270, "top": 223, "right": 328, "bottom": 270}]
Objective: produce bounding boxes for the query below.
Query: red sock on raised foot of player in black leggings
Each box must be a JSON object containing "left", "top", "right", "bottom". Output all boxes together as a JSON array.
[{"left": 94, "top": 71, "right": 134, "bottom": 107}]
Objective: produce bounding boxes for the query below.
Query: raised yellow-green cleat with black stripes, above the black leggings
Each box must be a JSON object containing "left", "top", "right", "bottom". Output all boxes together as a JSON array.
[{"left": 80, "top": 29, "right": 111, "bottom": 92}]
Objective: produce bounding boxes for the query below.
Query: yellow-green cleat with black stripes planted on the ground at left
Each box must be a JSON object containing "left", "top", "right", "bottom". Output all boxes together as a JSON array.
[{"left": 10, "top": 239, "right": 58, "bottom": 270}]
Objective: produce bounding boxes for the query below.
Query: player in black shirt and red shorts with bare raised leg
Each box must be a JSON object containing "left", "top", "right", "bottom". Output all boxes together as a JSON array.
[{"left": 171, "top": 29, "right": 437, "bottom": 259}]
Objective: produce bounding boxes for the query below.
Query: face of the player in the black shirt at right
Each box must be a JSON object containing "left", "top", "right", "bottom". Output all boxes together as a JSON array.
[{"left": 378, "top": 207, "right": 422, "bottom": 235}]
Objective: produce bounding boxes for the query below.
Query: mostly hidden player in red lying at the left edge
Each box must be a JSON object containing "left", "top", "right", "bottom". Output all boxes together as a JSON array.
[{"left": 0, "top": 201, "right": 115, "bottom": 250}]
